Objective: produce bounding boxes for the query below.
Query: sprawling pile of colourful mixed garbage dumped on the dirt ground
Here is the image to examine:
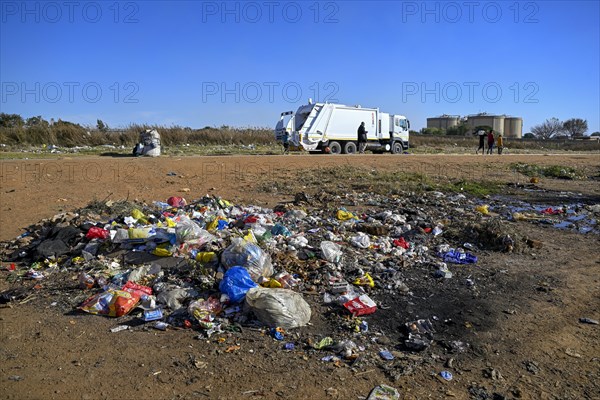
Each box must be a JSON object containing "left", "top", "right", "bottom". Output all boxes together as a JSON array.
[{"left": 0, "top": 192, "right": 596, "bottom": 370}]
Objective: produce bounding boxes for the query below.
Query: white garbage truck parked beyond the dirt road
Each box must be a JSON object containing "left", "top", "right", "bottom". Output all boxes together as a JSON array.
[{"left": 275, "top": 100, "right": 410, "bottom": 154}]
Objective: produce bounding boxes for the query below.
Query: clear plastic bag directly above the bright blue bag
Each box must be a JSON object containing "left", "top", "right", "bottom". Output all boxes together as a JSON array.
[{"left": 221, "top": 238, "right": 273, "bottom": 282}]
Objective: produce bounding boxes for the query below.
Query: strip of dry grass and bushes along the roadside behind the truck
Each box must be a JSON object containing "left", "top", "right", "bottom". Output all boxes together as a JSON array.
[{"left": 0, "top": 113, "right": 600, "bottom": 159}]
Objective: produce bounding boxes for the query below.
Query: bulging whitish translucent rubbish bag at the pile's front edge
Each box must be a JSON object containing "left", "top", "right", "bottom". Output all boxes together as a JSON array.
[{"left": 246, "top": 286, "right": 311, "bottom": 329}]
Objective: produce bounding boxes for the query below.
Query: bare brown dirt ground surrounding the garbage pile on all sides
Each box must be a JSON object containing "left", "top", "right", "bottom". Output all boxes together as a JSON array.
[{"left": 0, "top": 154, "right": 600, "bottom": 399}]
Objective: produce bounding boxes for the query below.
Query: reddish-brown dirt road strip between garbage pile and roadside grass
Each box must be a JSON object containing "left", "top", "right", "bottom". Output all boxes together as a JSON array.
[{"left": 0, "top": 154, "right": 600, "bottom": 240}]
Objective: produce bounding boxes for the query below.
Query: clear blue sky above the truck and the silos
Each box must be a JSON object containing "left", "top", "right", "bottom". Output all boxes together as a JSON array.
[{"left": 0, "top": 1, "right": 600, "bottom": 134}]
